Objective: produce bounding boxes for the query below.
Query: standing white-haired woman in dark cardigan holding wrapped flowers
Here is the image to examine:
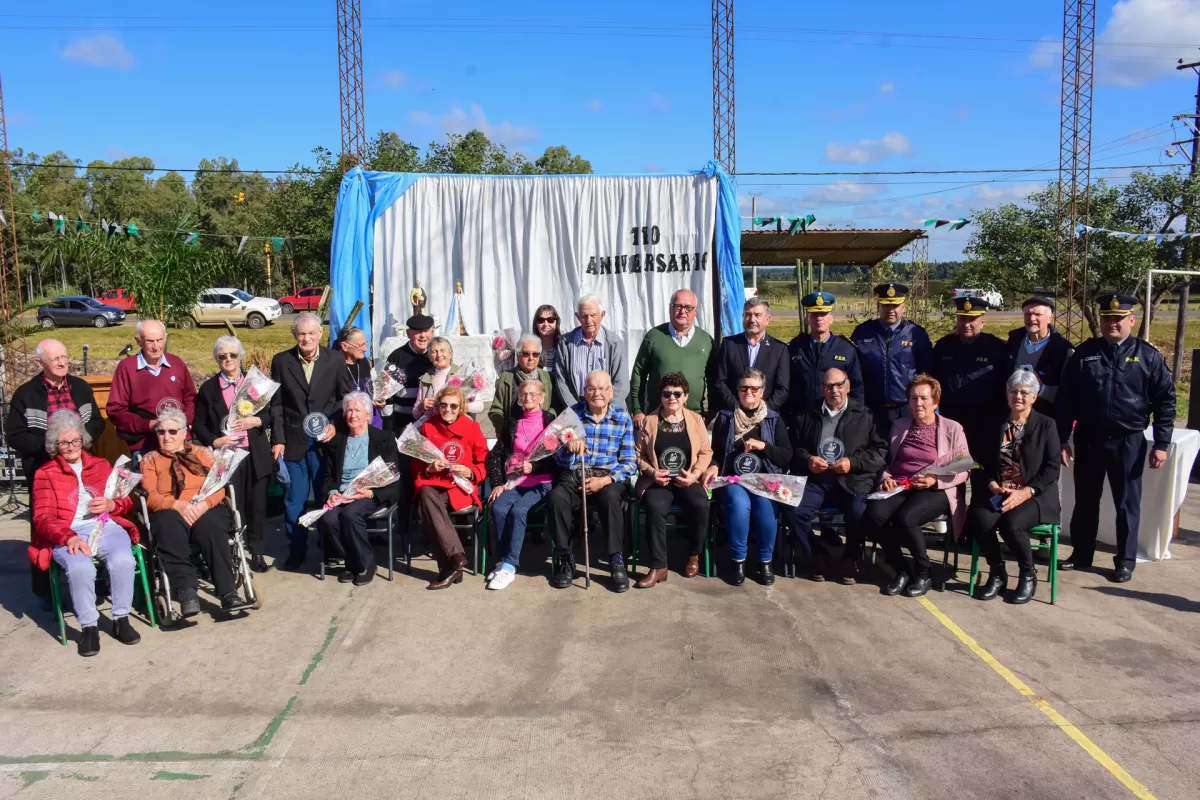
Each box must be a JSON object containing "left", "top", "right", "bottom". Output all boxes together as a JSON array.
[{"left": 192, "top": 336, "right": 275, "bottom": 572}]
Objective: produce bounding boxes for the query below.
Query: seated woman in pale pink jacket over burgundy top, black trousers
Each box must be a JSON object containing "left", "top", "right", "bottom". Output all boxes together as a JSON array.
[{"left": 860, "top": 374, "right": 970, "bottom": 597}]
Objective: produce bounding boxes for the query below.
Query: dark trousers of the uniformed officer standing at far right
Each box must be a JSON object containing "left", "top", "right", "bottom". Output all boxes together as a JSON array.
[{"left": 1070, "top": 431, "right": 1150, "bottom": 570}]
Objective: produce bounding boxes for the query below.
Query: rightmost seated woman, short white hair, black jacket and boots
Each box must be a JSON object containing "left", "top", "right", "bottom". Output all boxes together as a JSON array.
[{"left": 967, "top": 369, "right": 1061, "bottom": 603}]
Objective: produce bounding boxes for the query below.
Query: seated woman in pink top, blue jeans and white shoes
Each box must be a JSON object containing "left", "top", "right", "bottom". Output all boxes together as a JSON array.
[{"left": 486, "top": 378, "right": 558, "bottom": 591}]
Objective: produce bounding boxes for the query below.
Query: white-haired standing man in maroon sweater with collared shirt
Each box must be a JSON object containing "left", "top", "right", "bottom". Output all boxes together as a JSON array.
[{"left": 108, "top": 319, "right": 196, "bottom": 455}]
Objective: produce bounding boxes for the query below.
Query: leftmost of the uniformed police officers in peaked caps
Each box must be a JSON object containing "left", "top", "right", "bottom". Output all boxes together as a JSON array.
[{"left": 787, "top": 291, "right": 863, "bottom": 415}]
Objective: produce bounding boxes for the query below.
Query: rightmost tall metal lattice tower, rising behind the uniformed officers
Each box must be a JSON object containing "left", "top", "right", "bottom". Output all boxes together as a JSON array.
[{"left": 1055, "top": 0, "right": 1096, "bottom": 342}]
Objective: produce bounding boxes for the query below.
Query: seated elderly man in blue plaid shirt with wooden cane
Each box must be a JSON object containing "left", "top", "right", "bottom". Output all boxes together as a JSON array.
[{"left": 546, "top": 369, "right": 637, "bottom": 593}]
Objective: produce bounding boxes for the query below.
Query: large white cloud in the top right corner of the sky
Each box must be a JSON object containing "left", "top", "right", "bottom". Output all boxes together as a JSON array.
[{"left": 1096, "top": 0, "right": 1200, "bottom": 86}]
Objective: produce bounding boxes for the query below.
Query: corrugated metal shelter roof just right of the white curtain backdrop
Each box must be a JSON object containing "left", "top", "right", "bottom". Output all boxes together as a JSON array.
[{"left": 742, "top": 230, "right": 924, "bottom": 266}]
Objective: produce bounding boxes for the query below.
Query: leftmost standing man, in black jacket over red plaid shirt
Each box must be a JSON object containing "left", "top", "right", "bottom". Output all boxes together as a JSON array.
[{"left": 7, "top": 339, "right": 104, "bottom": 493}]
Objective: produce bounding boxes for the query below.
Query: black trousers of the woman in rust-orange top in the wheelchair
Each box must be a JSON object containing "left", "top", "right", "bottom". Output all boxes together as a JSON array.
[{"left": 150, "top": 505, "right": 236, "bottom": 597}]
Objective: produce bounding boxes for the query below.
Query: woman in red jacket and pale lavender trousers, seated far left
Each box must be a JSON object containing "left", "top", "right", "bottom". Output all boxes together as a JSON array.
[{"left": 29, "top": 410, "right": 142, "bottom": 656}]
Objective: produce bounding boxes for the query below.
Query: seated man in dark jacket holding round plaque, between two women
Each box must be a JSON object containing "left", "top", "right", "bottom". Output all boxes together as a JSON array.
[{"left": 784, "top": 368, "right": 888, "bottom": 585}]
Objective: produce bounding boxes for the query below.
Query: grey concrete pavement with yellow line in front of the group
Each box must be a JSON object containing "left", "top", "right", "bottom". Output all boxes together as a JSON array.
[{"left": 0, "top": 496, "right": 1200, "bottom": 800}]
